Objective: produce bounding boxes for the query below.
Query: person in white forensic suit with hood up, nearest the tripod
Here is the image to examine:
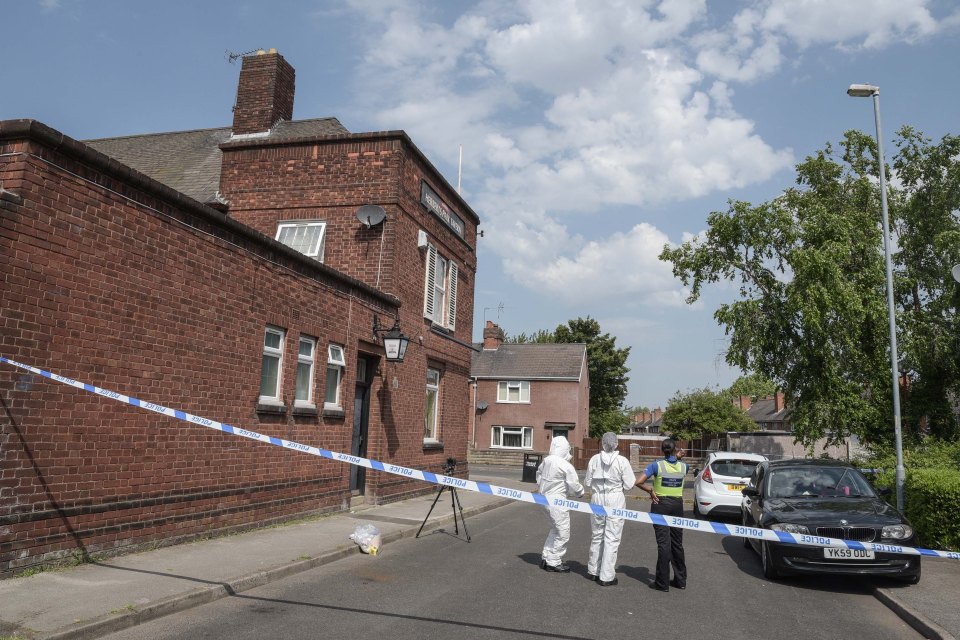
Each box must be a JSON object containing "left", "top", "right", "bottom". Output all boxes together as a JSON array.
[{"left": 537, "top": 436, "right": 583, "bottom": 571}]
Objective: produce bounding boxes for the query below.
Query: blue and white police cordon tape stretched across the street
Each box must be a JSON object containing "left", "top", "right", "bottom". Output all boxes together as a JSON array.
[{"left": 0, "top": 356, "right": 960, "bottom": 560}]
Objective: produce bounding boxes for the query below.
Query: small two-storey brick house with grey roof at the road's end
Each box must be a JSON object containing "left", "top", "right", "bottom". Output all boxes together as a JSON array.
[{"left": 470, "top": 321, "right": 590, "bottom": 464}]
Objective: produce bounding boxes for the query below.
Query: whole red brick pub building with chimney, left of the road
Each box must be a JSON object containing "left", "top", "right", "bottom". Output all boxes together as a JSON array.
[{"left": 0, "top": 50, "right": 479, "bottom": 574}]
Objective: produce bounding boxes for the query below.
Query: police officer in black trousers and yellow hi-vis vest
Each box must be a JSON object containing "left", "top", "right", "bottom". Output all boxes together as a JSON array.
[{"left": 636, "top": 439, "right": 687, "bottom": 591}]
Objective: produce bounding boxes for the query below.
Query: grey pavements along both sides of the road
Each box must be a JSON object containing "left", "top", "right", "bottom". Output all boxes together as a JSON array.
[{"left": 0, "top": 465, "right": 960, "bottom": 640}]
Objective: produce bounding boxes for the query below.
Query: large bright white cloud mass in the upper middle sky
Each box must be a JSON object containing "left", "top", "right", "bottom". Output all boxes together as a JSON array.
[{"left": 340, "top": 0, "right": 952, "bottom": 312}]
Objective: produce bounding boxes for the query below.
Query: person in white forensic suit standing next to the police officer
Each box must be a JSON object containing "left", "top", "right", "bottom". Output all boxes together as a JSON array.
[{"left": 584, "top": 431, "right": 637, "bottom": 583}]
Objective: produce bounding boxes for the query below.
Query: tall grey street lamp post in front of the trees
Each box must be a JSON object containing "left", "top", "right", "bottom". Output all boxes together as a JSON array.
[{"left": 847, "top": 84, "right": 906, "bottom": 511}]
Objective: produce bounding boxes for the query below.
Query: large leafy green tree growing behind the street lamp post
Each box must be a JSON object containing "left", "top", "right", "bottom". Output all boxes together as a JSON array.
[{"left": 660, "top": 129, "right": 960, "bottom": 443}]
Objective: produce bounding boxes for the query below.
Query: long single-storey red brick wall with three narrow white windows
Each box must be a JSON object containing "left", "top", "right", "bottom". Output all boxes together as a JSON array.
[{"left": 0, "top": 122, "right": 412, "bottom": 573}]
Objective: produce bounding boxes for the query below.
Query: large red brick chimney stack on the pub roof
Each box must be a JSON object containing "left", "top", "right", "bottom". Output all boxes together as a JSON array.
[{"left": 233, "top": 49, "right": 296, "bottom": 136}]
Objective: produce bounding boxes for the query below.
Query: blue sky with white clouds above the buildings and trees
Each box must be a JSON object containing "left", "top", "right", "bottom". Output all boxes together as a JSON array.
[{"left": 7, "top": 0, "right": 960, "bottom": 407}]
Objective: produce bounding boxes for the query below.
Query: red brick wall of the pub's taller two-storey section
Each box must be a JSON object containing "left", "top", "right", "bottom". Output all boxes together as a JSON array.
[{"left": 220, "top": 132, "right": 476, "bottom": 501}]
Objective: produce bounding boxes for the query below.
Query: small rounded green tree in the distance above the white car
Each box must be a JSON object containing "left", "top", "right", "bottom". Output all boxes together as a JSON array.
[{"left": 660, "top": 388, "right": 757, "bottom": 440}]
